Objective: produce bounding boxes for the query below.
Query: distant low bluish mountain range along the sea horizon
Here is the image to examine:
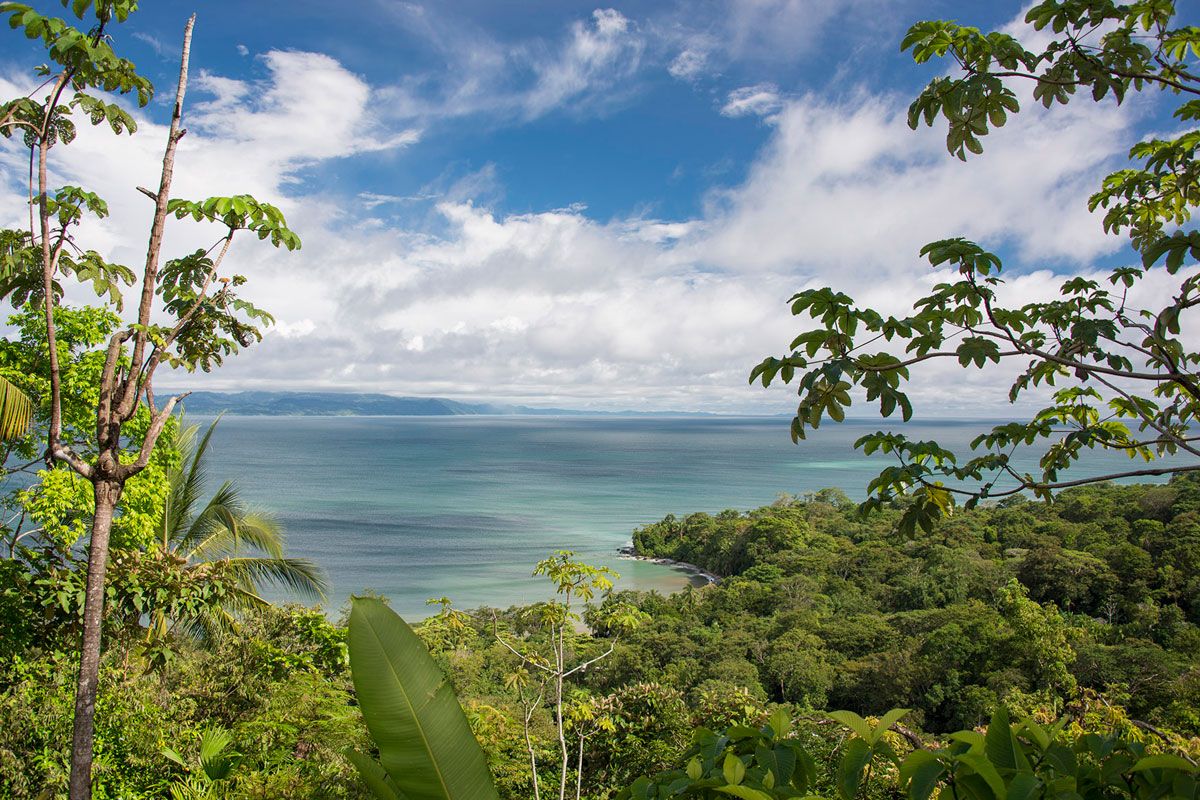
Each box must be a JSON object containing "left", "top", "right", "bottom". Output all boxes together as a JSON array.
[{"left": 172, "top": 392, "right": 712, "bottom": 416}]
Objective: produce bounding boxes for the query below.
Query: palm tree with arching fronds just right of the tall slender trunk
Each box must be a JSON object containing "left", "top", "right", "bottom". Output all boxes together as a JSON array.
[{"left": 150, "top": 420, "right": 328, "bottom": 637}]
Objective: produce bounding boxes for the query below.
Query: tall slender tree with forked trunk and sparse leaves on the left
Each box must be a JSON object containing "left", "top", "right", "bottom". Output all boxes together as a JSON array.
[{"left": 0, "top": 0, "right": 300, "bottom": 800}]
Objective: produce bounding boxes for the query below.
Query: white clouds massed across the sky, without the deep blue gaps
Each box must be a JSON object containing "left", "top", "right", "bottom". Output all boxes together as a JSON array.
[{"left": 0, "top": 6, "right": 1165, "bottom": 413}]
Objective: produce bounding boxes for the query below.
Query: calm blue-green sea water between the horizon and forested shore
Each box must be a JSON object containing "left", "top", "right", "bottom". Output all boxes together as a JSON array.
[{"left": 194, "top": 416, "right": 1180, "bottom": 618}]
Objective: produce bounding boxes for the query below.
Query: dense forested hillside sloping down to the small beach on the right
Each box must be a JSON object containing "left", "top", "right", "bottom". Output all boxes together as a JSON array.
[{"left": 623, "top": 477, "right": 1200, "bottom": 735}]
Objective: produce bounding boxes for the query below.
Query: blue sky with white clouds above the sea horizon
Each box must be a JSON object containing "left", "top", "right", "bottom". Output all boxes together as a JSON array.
[{"left": 0, "top": 0, "right": 1185, "bottom": 416}]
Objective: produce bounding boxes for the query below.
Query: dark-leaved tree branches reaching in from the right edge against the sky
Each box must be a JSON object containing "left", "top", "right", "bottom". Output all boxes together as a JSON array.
[{"left": 750, "top": 0, "right": 1200, "bottom": 533}]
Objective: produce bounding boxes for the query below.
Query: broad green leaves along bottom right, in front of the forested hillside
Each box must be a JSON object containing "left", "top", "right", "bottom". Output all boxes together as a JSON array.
[{"left": 616, "top": 709, "right": 1200, "bottom": 800}]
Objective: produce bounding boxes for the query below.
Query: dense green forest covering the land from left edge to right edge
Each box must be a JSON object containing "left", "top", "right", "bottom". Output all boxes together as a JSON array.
[{"left": 0, "top": 477, "right": 1200, "bottom": 800}]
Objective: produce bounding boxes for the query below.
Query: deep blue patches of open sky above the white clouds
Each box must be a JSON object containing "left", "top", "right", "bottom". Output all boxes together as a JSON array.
[{"left": 110, "top": 0, "right": 993, "bottom": 219}]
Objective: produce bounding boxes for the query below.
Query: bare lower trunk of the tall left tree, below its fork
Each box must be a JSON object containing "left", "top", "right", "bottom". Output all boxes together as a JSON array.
[{"left": 70, "top": 479, "right": 122, "bottom": 800}]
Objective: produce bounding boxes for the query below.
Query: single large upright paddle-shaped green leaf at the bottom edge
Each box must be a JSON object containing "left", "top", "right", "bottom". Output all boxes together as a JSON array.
[{"left": 349, "top": 597, "right": 498, "bottom": 800}]
